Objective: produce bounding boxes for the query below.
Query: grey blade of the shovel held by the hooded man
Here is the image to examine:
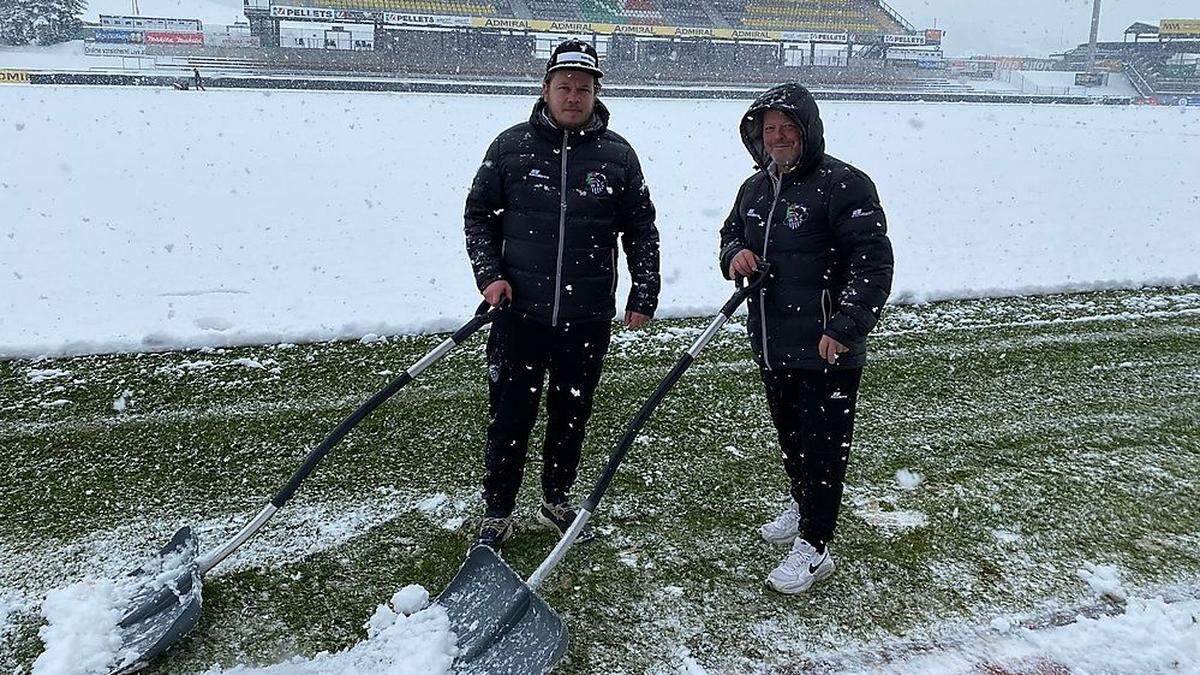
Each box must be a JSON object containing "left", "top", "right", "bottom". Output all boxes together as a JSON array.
[{"left": 437, "top": 546, "right": 566, "bottom": 674}]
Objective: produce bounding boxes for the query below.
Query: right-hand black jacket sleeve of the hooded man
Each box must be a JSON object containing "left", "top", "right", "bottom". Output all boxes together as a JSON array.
[{"left": 824, "top": 171, "right": 893, "bottom": 345}]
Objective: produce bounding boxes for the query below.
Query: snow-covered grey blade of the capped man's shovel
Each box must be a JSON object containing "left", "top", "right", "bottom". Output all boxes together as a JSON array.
[{"left": 109, "top": 527, "right": 200, "bottom": 675}]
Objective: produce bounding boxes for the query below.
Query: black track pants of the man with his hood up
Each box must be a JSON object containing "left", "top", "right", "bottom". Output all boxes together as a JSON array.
[{"left": 761, "top": 368, "right": 863, "bottom": 548}]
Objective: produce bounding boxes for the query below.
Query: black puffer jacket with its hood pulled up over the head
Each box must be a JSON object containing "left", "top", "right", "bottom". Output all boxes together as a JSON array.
[{"left": 720, "top": 84, "right": 893, "bottom": 369}]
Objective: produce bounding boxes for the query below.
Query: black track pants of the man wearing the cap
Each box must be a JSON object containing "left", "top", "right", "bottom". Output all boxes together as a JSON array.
[{"left": 484, "top": 312, "right": 611, "bottom": 516}]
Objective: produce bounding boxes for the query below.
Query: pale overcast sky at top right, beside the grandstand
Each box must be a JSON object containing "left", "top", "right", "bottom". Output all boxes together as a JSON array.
[{"left": 886, "top": 0, "right": 1200, "bottom": 56}]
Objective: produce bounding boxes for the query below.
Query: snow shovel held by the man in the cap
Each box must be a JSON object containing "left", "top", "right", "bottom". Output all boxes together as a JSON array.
[{"left": 96, "top": 303, "right": 504, "bottom": 675}]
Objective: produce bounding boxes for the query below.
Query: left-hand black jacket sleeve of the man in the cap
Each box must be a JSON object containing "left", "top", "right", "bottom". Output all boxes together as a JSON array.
[{"left": 463, "top": 138, "right": 504, "bottom": 291}]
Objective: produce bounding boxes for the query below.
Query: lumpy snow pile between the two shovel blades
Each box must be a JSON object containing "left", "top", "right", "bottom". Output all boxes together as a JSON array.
[{"left": 205, "top": 585, "right": 458, "bottom": 675}]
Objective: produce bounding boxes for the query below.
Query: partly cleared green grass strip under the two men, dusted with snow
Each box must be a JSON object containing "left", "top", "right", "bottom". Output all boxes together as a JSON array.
[{"left": 0, "top": 286, "right": 1200, "bottom": 674}]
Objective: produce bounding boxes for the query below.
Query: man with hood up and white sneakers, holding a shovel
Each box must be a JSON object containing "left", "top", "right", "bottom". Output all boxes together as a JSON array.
[{"left": 720, "top": 83, "right": 893, "bottom": 593}]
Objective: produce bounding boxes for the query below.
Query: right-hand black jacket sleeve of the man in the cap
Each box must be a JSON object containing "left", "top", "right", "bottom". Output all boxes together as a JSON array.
[{"left": 619, "top": 148, "right": 661, "bottom": 316}]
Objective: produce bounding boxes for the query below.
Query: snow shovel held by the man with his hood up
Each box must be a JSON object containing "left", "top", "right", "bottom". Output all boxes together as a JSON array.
[{"left": 437, "top": 262, "right": 768, "bottom": 674}]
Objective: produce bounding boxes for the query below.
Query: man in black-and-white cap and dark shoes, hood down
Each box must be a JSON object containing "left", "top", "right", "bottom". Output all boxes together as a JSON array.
[{"left": 466, "top": 40, "right": 660, "bottom": 549}]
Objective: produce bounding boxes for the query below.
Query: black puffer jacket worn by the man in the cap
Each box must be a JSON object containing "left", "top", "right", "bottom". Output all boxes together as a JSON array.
[{"left": 466, "top": 100, "right": 660, "bottom": 325}]
